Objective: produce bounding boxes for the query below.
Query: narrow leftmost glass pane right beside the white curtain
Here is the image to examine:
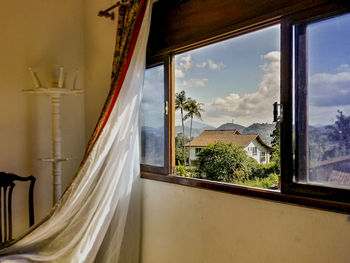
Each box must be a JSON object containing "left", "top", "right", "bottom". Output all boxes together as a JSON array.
[{"left": 141, "top": 65, "right": 164, "bottom": 167}]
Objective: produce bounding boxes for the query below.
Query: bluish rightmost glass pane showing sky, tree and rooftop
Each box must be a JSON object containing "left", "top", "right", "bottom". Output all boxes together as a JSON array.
[{"left": 300, "top": 14, "right": 350, "bottom": 188}]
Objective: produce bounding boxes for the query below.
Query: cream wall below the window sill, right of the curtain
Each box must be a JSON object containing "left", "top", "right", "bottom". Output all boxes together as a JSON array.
[{"left": 142, "top": 179, "right": 350, "bottom": 263}]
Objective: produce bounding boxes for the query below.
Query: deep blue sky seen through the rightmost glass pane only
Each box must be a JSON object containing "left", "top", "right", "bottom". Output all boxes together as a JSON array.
[{"left": 307, "top": 12, "right": 350, "bottom": 125}]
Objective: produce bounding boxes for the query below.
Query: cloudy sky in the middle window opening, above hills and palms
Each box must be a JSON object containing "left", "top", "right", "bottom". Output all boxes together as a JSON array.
[{"left": 175, "top": 25, "right": 280, "bottom": 127}]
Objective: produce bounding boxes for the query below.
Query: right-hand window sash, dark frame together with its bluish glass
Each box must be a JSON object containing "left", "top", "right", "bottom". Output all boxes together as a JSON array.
[{"left": 282, "top": 7, "right": 350, "bottom": 203}]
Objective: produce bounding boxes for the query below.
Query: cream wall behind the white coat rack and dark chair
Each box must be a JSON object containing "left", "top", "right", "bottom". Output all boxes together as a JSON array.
[{"left": 0, "top": 0, "right": 85, "bottom": 237}]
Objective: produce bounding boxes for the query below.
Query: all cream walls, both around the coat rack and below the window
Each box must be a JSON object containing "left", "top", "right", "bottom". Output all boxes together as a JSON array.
[{"left": 0, "top": 0, "right": 350, "bottom": 263}]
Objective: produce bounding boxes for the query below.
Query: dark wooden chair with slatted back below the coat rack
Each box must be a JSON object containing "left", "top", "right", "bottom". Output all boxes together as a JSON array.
[{"left": 0, "top": 172, "right": 35, "bottom": 243}]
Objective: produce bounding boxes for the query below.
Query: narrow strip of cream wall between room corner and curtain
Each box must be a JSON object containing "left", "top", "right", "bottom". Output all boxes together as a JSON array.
[{"left": 84, "top": 0, "right": 117, "bottom": 142}]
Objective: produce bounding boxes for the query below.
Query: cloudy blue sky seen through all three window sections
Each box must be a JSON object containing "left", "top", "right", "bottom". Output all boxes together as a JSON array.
[{"left": 143, "top": 15, "right": 350, "bottom": 127}]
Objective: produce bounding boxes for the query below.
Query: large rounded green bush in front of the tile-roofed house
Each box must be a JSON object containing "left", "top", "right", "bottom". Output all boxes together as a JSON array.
[{"left": 198, "top": 141, "right": 252, "bottom": 183}]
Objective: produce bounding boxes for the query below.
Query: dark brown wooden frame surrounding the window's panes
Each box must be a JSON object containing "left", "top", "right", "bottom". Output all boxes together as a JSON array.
[{"left": 141, "top": 2, "right": 350, "bottom": 214}]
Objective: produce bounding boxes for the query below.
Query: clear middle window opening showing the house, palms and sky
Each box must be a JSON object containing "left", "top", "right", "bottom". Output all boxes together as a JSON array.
[{"left": 175, "top": 25, "right": 280, "bottom": 189}]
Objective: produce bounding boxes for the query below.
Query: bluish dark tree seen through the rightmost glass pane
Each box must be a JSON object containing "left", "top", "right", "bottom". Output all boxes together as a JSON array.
[{"left": 326, "top": 110, "right": 350, "bottom": 154}]
